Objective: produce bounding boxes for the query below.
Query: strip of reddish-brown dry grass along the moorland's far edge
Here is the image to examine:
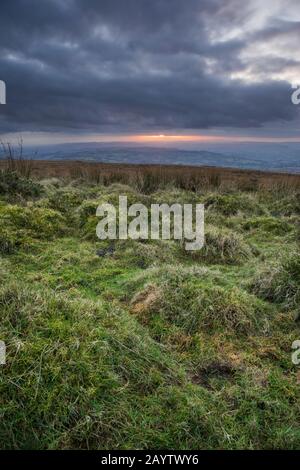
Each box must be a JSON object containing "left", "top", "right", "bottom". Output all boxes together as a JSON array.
[{"left": 0, "top": 158, "right": 300, "bottom": 194}]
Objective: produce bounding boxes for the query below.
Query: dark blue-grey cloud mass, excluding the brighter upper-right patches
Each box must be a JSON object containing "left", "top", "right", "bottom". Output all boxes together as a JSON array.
[{"left": 0, "top": 0, "right": 297, "bottom": 133}]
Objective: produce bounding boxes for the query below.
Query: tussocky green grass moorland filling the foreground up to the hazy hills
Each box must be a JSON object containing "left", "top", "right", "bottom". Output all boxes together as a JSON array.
[{"left": 0, "top": 162, "right": 300, "bottom": 449}]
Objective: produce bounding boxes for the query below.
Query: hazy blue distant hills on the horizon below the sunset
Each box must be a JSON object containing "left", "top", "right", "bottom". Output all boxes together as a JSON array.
[{"left": 2, "top": 142, "right": 300, "bottom": 173}]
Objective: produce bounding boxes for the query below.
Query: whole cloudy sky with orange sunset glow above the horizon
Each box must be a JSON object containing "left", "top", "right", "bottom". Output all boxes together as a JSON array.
[{"left": 0, "top": 0, "right": 300, "bottom": 145}]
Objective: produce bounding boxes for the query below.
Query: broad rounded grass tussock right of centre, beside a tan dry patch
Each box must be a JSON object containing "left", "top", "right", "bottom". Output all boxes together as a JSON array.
[{"left": 143, "top": 279, "right": 268, "bottom": 334}]
